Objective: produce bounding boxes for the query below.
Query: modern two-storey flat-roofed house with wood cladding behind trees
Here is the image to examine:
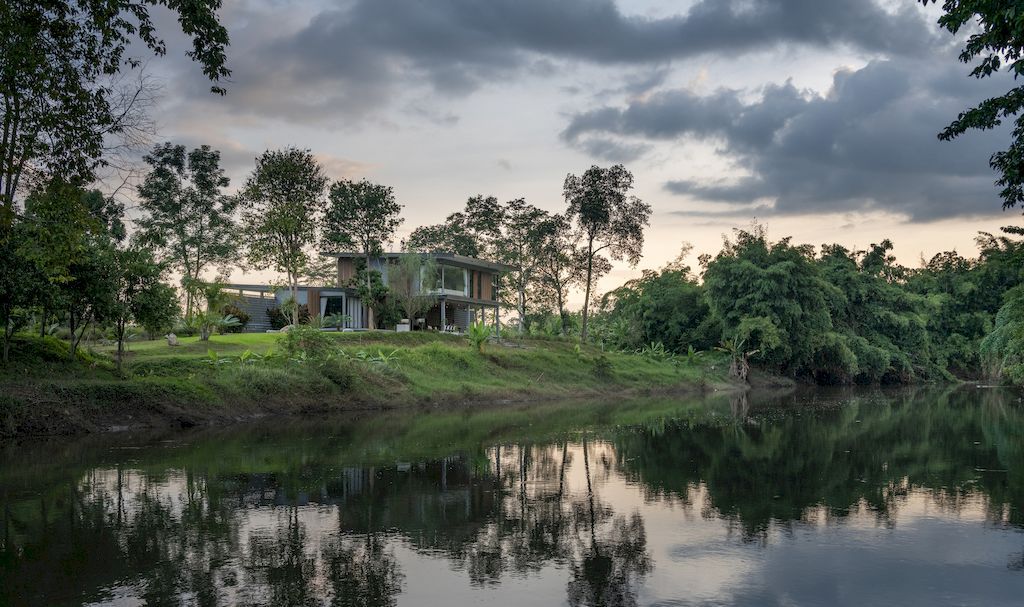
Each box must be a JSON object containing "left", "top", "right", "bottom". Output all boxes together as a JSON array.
[{"left": 224, "top": 253, "right": 510, "bottom": 332}]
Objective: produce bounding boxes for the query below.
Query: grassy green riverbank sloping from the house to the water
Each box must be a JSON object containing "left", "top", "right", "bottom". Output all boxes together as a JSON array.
[{"left": 0, "top": 332, "right": 733, "bottom": 437}]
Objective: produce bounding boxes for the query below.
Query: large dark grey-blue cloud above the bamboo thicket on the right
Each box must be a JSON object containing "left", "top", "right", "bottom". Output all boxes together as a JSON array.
[{"left": 562, "top": 58, "right": 1011, "bottom": 220}]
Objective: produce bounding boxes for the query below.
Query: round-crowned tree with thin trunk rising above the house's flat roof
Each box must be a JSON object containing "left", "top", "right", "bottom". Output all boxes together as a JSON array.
[{"left": 324, "top": 179, "right": 402, "bottom": 329}]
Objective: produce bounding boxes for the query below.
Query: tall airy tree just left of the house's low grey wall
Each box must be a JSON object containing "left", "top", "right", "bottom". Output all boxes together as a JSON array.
[{"left": 138, "top": 142, "right": 239, "bottom": 315}]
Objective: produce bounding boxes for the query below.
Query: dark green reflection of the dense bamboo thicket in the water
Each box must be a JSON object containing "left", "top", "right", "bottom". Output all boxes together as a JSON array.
[{"left": 614, "top": 384, "right": 1024, "bottom": 539}]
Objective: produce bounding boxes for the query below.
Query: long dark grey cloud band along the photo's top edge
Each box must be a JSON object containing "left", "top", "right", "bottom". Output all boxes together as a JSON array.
[{"left": 211, "top": 0, "right": 937, "bottom": 122}]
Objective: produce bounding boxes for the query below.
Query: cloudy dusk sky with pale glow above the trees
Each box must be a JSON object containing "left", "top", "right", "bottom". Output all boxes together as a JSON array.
[{"left": 132, "top": 0, "right": 1021, "bottom": 299}]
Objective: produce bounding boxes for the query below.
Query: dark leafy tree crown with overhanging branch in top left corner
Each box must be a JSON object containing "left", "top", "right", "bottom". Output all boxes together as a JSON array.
[{"left": 0, "top": 0, "right": 230, "bottom": 230}]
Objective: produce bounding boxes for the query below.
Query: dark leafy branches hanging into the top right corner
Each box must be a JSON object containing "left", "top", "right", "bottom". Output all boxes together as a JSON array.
[{"left": 921, "top": 0, "right": 1024, "bottom": 209}]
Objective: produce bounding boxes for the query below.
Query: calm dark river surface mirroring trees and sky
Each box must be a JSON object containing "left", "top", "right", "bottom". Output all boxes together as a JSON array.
[{"left": 0, "top": 389, "right": 1024, "bottom": 607}]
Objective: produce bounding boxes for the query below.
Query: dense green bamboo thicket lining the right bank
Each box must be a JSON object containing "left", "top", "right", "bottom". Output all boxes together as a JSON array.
[{"left": 599, "top": 226, "right": 1024, "bottom": 384}]
